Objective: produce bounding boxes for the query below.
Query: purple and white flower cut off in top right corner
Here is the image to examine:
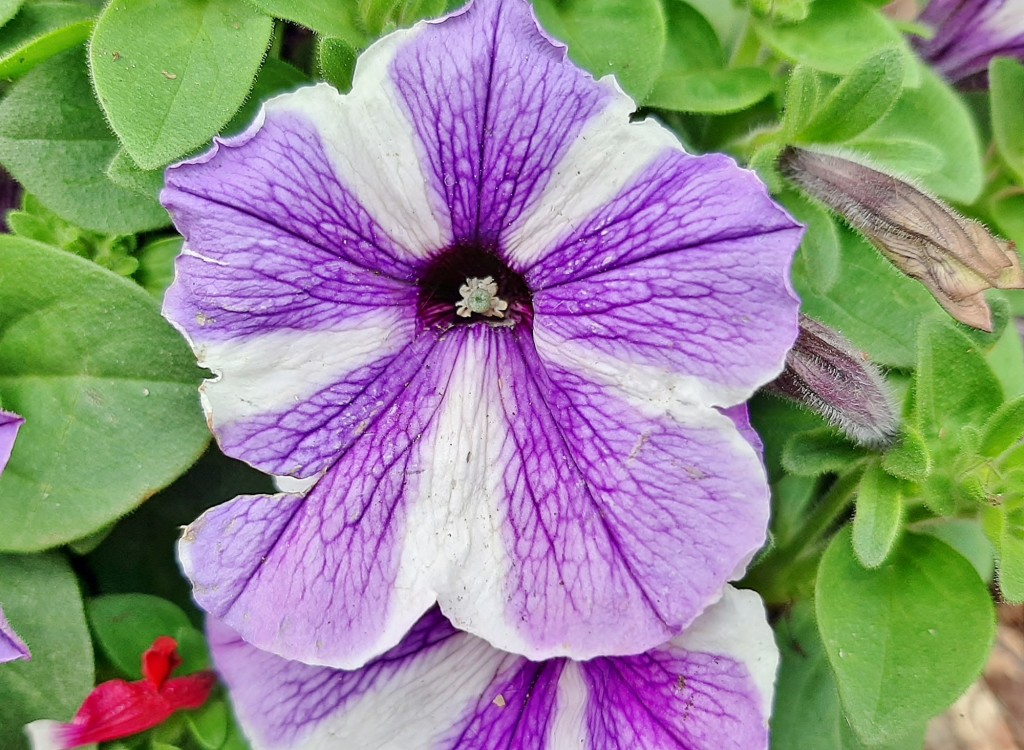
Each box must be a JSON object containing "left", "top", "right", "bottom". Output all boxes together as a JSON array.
[{"left": 915, "top": 0, "right": 1024, "bottom": 86}]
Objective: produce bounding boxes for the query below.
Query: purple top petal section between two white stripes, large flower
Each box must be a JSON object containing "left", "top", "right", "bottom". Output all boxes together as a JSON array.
[{"left": 390, "top": 0, "right": 614, "bottom": 244}]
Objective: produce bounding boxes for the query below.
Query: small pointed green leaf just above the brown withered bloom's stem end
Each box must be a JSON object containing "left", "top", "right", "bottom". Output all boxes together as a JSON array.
[{"left": 798, "top": 47, "right": 904, "bottom": 143}]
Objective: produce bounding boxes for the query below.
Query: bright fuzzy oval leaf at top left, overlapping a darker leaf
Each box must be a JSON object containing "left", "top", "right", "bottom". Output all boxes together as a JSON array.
[{"left": 89, "top": 0, "right": 273, "bottom": 169}]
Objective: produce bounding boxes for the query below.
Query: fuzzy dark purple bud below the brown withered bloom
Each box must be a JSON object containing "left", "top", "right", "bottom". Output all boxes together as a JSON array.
[{"left": 765, "top": 315, "right": 899, "bottom": 448}]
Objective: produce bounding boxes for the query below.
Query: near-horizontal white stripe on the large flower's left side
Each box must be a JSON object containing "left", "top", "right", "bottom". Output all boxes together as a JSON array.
[{"left": 195, "top": 307, "right": 415, "bottom": 426}]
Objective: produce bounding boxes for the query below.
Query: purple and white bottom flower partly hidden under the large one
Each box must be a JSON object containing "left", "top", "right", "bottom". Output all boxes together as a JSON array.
[{"left": 208, "top": 588, "right": 778, "bottom": 750}]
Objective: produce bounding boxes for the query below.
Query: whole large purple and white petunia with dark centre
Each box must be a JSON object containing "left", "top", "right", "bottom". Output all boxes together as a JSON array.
[{"left": 162, "top": 0, "right": 802, "bottom": 668}]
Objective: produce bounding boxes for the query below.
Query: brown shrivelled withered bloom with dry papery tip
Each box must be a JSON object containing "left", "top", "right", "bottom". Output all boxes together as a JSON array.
[{"left": 779, "top": 147, "right": 1024, "bottom": 331}]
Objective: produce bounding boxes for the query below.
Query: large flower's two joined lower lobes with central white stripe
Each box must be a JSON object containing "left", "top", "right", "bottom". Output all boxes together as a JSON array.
[{"left": 179, "top": 326, "right": 768, "bottom": 668}]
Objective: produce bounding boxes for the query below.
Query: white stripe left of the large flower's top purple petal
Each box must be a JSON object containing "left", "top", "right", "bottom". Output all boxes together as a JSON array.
[{"left": 266, "top": 33, "right": 452, "bottom": 257}]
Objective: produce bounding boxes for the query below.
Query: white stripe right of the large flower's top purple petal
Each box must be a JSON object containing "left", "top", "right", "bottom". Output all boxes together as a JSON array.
[{"left": 505, "top": 85, "right": 682, "bottom": 270}]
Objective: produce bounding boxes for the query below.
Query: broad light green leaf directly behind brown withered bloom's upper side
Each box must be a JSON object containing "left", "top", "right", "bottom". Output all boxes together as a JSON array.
[{"left": 848, "top": 66, "right": 985, "bottom": 203}]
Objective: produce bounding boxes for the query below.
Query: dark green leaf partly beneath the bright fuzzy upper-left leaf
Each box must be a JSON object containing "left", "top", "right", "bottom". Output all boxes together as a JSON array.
[{"left": 0, "top": 50, "right": 170, "bottom": 234}]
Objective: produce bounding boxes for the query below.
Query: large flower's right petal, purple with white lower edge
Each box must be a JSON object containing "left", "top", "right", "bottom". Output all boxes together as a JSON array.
[{"left": 526, "top": 151, "right": 802, "bottom": 406}]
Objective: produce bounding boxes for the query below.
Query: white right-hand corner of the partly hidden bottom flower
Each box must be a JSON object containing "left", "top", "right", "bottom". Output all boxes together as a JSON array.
[{"left": 672, "top": 586, "right": 778, "bottom": 719}]
